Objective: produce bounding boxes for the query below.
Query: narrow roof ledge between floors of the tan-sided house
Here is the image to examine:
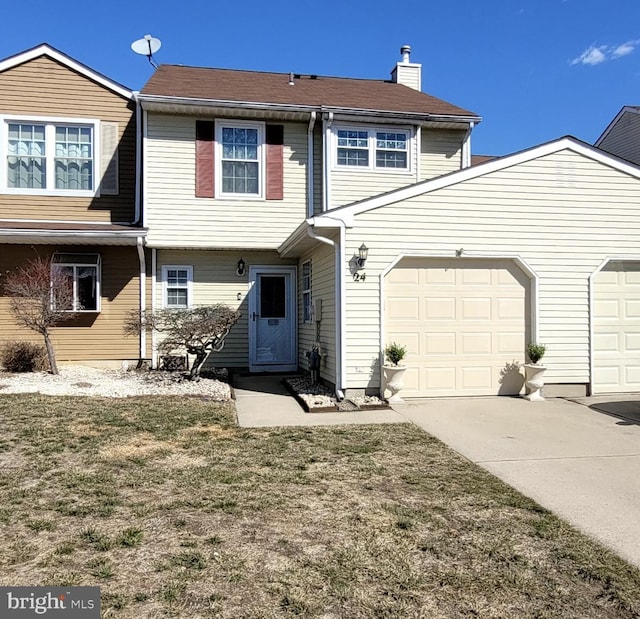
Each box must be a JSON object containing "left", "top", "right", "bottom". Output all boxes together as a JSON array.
[{"left": 0, "top": 221, "right": 147, "bottom": 245}]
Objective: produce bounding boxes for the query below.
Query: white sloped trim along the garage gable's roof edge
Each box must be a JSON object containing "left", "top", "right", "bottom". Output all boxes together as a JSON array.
[{"left": 313, "top": 136, "right": 640, "bottom": 225}]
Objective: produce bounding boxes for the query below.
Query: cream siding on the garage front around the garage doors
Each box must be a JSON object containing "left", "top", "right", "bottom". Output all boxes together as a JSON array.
[{"left": 347, "top": 150, "right": 640, "bottom": 387}]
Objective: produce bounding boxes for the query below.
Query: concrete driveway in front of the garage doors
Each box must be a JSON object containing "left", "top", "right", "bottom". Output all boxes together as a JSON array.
[{"left": 394, "top": 396, "right": 640, "bottom": 566}]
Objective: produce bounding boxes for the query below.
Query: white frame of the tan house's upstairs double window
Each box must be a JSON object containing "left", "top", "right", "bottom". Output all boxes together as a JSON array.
[{"left": 0, "top": 114, "right": 102, "bottom": 198}]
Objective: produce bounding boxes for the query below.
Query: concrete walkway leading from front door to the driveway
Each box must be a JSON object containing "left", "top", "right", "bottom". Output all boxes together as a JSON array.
[{"left": 234, "top": 376, "right": 408, "bottom": 428}]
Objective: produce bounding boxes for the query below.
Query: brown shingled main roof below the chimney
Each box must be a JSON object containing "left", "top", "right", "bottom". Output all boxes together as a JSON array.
[{"left": 141, "top": 65, "right": 479, "bottom": 120}]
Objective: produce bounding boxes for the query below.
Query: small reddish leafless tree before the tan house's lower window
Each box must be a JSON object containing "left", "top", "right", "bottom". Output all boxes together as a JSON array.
[{"left": 4, "top": 257, "right": 76, "bottom": 374}]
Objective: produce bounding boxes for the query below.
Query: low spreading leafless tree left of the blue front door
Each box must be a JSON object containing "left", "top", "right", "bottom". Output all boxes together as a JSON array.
[{"left": 125, "top": 303, "right": 241, "bottom": 380}]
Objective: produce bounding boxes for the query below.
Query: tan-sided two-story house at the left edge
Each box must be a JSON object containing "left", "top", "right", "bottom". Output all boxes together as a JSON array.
[{"left": 0, "top": 45, "right": 147, "bottom": 365}]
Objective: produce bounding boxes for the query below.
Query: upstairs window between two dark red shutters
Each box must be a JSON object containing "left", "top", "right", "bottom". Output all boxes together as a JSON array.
[{"left": 216, "top": 122, "right": 264, "bottom": 197}]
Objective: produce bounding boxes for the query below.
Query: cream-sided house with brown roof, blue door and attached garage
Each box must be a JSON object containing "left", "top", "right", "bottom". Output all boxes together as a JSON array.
[{"left": 139, "top": 47, "right": 640, "bottom": 396}]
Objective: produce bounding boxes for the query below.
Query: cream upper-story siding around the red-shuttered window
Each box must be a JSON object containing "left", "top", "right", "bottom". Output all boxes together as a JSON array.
[{"left": 145, "top": 113, "right": 307, "bottom": 249}]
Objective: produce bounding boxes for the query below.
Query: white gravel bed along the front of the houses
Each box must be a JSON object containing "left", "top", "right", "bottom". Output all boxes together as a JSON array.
[{"left": 0, "top": 365, "right": 231, "bottom": 401}]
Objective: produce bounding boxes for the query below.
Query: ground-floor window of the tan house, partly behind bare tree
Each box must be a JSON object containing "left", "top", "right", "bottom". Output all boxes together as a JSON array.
[{"left": 51, "top": 253, "right": 100, "bottom": 312}]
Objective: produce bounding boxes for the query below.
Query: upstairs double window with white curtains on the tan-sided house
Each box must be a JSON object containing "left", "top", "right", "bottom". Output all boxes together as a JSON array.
[{"left": 2, "top": 118, "right": 96, "bottom": 195}]
